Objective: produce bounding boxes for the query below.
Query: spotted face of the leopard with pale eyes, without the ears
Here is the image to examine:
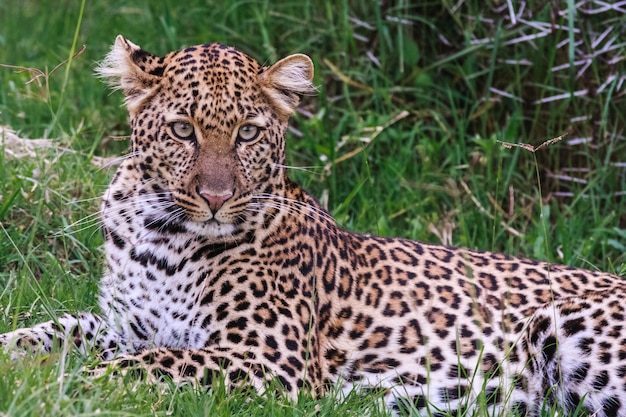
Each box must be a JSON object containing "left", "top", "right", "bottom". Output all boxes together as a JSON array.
[{"left": 132, "top": 45, "right": 286, "bottom": 235}]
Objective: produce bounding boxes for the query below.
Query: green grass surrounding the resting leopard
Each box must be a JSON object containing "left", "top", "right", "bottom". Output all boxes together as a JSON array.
[{"left": 0, "top": 0, "right": 626, "bottom": 416}]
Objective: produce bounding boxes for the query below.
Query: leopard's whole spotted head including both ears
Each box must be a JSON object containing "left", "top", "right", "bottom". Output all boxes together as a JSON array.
[{"left": 97, "top": 36, "right": 315, "bottom": 237}]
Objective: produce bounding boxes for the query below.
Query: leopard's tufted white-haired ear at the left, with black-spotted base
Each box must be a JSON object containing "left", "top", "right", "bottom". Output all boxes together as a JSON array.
[{"left": 96, "top": 35, "right": 165, "bottom": 113}]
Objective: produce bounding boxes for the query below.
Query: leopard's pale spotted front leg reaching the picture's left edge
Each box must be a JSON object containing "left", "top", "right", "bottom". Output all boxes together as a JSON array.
[{"left": 0, "top": 313, "right": 117, "bottom": 358}]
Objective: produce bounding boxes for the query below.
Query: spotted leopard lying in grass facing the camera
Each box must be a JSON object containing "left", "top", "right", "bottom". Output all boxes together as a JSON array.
[{"left": 0, "top": 35, "right": 626, "bottom": 416}]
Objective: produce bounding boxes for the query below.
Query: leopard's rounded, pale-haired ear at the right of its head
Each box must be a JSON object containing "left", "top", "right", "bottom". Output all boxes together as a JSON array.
[{"left": 259, "top": 54, "right": 317, "bottom": 116}]
